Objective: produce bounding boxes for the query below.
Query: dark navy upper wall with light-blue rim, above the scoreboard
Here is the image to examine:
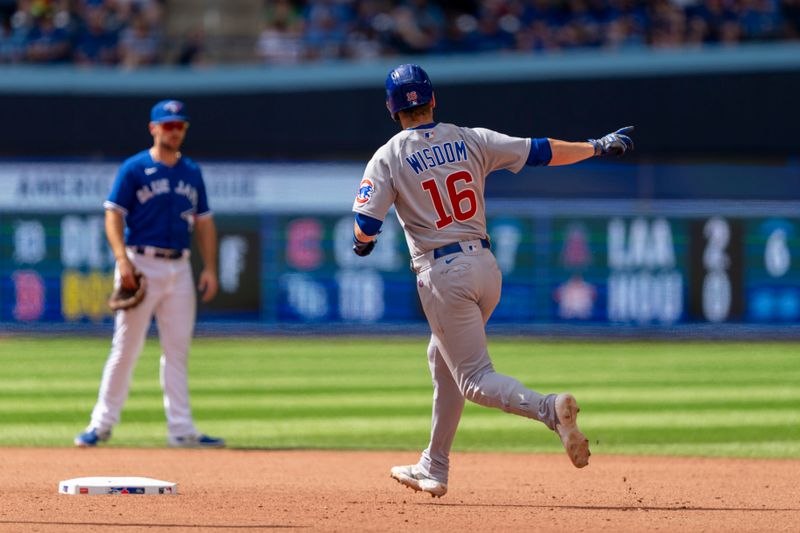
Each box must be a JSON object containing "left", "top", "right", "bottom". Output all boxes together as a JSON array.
[{"left": 0, "top": 44, "right": 800, "bottom": 160}]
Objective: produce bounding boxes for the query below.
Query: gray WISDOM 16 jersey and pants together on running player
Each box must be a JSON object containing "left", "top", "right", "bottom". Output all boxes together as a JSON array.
[{"left": 353, "top": 120, "right": 554, "bottom": 484}]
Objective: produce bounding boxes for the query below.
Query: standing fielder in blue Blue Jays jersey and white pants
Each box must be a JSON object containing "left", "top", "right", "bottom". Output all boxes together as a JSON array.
[{"left": 75, "top": 100, "right": 225, "bottom": 448}]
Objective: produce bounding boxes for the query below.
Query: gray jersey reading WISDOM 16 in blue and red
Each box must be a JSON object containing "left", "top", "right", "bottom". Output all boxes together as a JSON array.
[{"left": 353, "top": 123, "right": 531, "bottom": 257}]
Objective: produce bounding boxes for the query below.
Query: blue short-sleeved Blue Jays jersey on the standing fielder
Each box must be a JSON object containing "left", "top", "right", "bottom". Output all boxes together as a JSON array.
[{"left": 103, "top": 150, "right": 211, "bottom": 250}]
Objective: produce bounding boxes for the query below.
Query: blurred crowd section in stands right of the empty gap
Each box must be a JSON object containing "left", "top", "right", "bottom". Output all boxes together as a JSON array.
[{"left": 258, "top": 0, "right": 800, "bottom": 63}]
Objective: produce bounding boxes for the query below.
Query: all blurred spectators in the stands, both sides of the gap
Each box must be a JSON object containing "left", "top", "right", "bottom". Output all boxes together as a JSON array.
[{"left": 0, "top": 0, "right": 800, "bottom": 68}]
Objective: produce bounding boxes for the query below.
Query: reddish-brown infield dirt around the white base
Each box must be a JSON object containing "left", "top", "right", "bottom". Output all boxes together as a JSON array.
[{"left": 0, "top": 448, "right": 800, "bottom": 533}]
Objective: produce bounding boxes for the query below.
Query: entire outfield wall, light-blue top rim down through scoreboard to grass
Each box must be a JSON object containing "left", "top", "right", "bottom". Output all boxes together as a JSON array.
[{"left": 0, "top": 44, "right": 800, "bottom": 338}]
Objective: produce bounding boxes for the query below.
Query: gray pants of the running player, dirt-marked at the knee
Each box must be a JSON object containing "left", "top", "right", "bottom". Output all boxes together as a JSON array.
[{"left": 417, "top": 248, "right": 554, "bottom": 483}]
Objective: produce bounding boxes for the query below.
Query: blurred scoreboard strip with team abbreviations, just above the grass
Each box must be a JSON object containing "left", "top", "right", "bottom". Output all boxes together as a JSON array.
[{"left": 0, "top": 207, "right": 800, "bottom": 327}]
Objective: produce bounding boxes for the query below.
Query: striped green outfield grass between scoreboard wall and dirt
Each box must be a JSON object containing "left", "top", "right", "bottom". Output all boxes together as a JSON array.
[{"left": 0, "top": 337, "right": 800, "bottom": 458}]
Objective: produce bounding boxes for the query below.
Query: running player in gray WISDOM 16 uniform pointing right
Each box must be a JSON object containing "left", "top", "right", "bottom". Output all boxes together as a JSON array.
[{"left": 353, "top": 65, "right": 633, "bottom": 497}]
